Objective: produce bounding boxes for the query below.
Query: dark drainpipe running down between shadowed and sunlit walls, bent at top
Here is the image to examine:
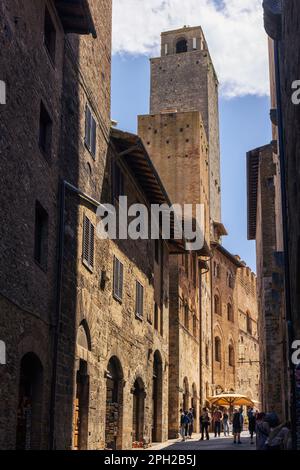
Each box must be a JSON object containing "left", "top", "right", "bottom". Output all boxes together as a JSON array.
[{"left": 49, "top": 180, "right": 100, "bottom": 450}]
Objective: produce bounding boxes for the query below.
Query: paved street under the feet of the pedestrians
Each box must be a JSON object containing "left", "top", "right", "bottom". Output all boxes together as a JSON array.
[{"left": 151, "top": 431, "right": 256, "bottom": 451}]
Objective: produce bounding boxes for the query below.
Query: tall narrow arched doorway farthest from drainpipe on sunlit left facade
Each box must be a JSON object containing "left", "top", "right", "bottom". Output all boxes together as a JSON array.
[{"left": 152, "top": 351, "right": 163, "bottom": 442}]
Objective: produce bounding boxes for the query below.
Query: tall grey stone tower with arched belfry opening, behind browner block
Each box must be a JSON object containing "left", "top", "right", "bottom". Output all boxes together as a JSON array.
[{"left": 150, "top": 26, "right": 221, "bottom": 222}]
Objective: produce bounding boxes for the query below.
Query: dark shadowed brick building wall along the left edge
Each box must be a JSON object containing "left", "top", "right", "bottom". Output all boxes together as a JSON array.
[{"left": 0, "top": 1, "right": 94, "bottom": 449}]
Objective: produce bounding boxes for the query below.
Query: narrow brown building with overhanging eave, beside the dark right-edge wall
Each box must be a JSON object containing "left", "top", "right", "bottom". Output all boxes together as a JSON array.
[{"left": 247, "top": 144, "right": 287, "bottom": 419}]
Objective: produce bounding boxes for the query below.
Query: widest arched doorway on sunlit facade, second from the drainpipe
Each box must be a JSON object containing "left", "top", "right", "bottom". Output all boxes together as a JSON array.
[{"left": 105, "top": 356, "right": 123, "bottom": 450}]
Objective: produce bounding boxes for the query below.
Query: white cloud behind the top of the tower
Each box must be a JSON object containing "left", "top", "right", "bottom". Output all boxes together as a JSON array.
[{"left": 113, "top": 0, "right": 269, "bottom": 98}]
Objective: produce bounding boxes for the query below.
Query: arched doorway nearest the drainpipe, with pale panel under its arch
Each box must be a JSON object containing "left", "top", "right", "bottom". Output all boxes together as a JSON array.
[{"left": 73, "top": 320, "right": 92, "bottom": 450}]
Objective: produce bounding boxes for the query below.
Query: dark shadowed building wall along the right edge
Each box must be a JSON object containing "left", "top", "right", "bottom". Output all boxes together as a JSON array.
[{"left": 256, "top": 0, "right": 300, "bottom": 448}]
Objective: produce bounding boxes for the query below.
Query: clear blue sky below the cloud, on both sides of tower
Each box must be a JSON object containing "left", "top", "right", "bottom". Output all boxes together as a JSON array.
[{"left": 112, "top": 54, "right": 271, "bottom": 270}]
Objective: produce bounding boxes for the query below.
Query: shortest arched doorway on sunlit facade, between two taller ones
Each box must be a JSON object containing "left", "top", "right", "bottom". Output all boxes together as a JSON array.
[{"left": 132, "top": 377, "right": 145, "bottom": 442}]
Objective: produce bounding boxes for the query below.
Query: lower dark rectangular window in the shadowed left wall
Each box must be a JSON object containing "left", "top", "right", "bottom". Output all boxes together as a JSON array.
[{"left": 34, "top": 202, "right": 48, "bottom": 270}]
